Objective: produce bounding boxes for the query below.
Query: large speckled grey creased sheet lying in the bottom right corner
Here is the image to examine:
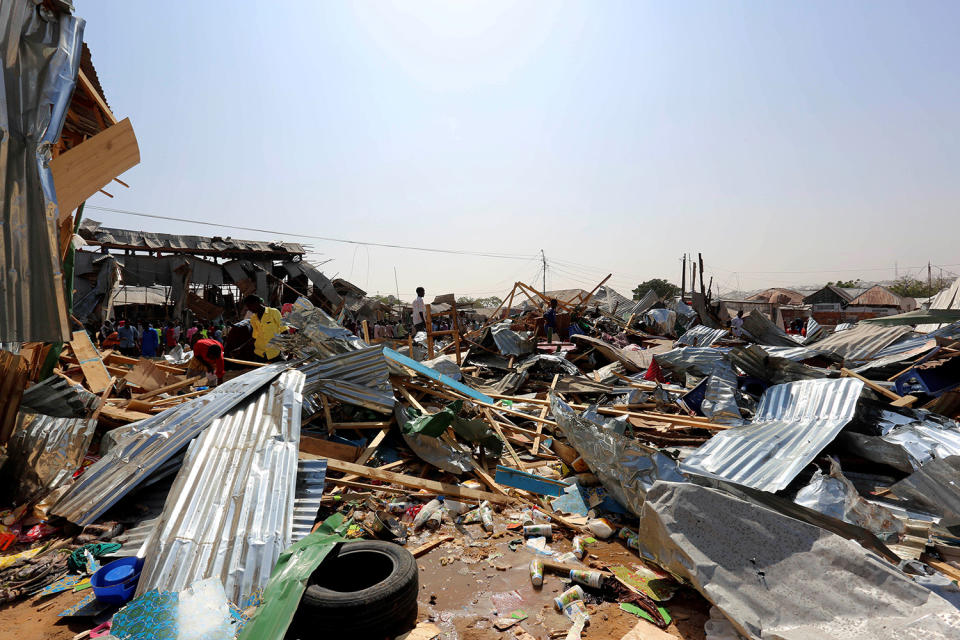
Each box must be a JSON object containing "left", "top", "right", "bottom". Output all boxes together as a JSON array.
[{"left": 639, "top": 482, "right": 960, "bottom": 640}]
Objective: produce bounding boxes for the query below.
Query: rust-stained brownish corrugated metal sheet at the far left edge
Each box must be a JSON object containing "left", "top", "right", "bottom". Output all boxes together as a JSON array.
[{"left": 7, "top": 411, "right": 97, "bottom": 504}]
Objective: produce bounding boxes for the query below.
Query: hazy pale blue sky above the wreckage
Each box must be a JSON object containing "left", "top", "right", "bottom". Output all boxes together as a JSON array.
[{"left": 75, "top": 0, "right": 960, "bottom": 299}]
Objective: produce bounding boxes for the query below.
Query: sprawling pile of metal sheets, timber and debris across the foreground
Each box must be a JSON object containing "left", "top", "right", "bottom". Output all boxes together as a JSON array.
[{"left": 0, "top": 282, "right": 960, "bottom": 639}]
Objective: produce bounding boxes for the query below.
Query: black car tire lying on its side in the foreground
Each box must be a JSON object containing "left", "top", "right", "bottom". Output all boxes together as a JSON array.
[{"left": 292, "top": 540, "right": 420, "bottom": 639}]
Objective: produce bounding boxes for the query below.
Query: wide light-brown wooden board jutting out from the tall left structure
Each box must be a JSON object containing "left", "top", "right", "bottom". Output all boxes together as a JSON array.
[{"left": 50, "top": 118, "right": 140, "bottom": 220}]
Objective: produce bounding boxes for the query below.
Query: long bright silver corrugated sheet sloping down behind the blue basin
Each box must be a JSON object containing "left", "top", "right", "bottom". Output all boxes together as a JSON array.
[{"left": 137, "top": 370, "right": 304, "bottom": 603}]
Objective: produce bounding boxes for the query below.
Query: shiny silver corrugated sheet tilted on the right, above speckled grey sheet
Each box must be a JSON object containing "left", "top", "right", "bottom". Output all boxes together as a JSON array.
[{"left": 681, "top": 378, "right": 863, "bottom": 491}]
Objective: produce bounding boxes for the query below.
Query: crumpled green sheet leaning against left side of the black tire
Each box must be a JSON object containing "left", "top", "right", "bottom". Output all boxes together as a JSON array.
[{"left": 239, "top": 513, "right": 349, "bottom": 640}]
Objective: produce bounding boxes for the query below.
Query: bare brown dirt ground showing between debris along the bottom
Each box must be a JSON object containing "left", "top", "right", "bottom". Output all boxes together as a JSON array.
[{"left": 0, "top": 525, "right": 709, "bottom": 640}]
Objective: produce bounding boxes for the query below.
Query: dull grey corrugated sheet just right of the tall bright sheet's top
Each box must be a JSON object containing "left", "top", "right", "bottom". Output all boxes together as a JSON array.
[{"left": 298, "top": 346, "right": 396, "bottom": 413}]
